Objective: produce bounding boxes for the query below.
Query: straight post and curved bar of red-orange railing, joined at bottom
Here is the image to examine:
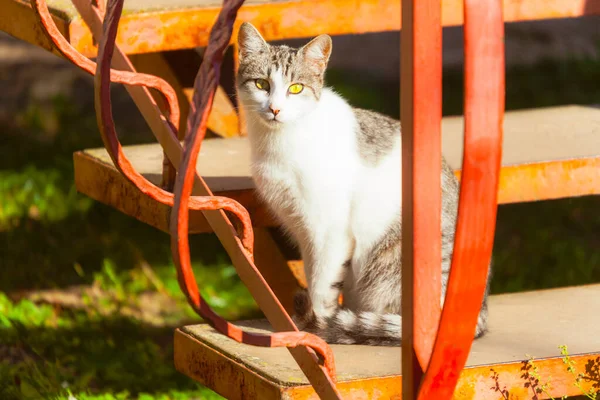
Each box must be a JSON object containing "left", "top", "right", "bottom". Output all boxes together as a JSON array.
[{"left": 401, "top": 0, "right": 505, "bottom": 399}]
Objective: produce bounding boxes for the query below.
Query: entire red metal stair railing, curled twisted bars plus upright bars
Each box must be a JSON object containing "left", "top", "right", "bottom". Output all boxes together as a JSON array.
[{"left": 30, "top": 0, "right": 504, "bottom": 399}]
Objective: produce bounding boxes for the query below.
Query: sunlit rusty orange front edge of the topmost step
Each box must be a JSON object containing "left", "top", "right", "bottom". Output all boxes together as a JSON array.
[{"left": 64, "top": 0, "right": 600, "bottom": 56}]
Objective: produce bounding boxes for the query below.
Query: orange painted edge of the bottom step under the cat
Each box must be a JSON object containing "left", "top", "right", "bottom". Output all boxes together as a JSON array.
[{"left": 174, "top": 329, "right": 600, "bottom": 400}]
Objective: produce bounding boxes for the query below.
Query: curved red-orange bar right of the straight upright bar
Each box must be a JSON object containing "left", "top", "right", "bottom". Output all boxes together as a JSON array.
[{"left": 419, "top": 0, "right": 505, "bottom": 399}]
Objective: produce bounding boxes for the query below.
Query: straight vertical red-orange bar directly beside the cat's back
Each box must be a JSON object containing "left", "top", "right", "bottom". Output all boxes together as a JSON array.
[{"left": 400, "top": 0, "right": 442, "bottom": 399}]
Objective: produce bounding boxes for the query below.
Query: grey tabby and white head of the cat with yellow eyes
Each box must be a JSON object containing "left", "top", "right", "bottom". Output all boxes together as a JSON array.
[{"left": 236, "top": 22, "right": 331, "bottom": 128}]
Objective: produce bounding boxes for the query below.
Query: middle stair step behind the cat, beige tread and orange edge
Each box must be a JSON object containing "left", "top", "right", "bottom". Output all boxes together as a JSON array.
[{"left": 74, "top": 105, "right": 600, "bottom": 233}]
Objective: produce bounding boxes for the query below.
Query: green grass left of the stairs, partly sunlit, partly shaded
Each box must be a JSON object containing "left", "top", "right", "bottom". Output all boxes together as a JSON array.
[{"left": 0, "top": 93, "right": 252, "bottom": 400}]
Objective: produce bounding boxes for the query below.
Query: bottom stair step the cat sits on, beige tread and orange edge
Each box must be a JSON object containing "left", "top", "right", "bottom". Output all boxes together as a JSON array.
[{"left": 175, "top": 284, "right": 600, "bottom": 400}]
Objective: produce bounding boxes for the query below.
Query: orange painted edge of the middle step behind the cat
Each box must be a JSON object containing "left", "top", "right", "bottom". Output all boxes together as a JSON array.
[{"left": 73, "top": 145, "right": 600, "bottom": 233}]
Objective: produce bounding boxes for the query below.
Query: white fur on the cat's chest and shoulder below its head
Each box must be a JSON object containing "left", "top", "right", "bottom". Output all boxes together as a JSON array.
[{"left": 248, "top": 90, "right": 401, "bottom": 268}]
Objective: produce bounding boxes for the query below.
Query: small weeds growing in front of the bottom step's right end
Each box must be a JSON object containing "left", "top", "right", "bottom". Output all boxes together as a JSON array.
[{"left": 490, "top": 345, "right": 600, "bottom": 400}]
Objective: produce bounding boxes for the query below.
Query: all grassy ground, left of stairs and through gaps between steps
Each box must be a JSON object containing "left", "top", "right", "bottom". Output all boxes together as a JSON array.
[{"left": 0, "top": 42, "right": 600, "bottom": 400}]
